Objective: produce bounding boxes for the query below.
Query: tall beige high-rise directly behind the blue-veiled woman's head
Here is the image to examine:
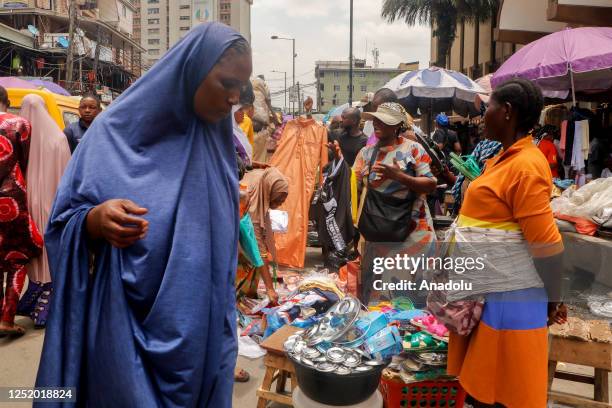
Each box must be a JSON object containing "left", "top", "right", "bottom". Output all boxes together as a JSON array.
[{"left": 138, "top": 0, "right": 253, "bottom": 66}]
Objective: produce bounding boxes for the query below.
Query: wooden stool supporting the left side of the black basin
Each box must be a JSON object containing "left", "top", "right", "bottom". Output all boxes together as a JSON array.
[{"left": 257, "top": 326, "right": 299, "bottom": 408}]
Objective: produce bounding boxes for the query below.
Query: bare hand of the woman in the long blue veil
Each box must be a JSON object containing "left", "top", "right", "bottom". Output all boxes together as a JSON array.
[{"left": 87, "top": 199, "right": 149, "bottom": 248}]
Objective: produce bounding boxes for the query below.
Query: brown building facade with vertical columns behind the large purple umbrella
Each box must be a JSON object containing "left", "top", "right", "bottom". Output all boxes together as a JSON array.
[{"left": 431, "top": 0, "right": 612, "bottom": 79}]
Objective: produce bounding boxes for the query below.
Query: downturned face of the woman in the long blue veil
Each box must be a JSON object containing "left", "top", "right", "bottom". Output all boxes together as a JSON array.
[{"left": 193, "top": 50, "right": 253, "bottom": 123}]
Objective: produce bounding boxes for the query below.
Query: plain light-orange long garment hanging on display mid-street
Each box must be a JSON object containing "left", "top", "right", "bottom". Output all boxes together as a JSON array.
[{"left": 270, "top": 118, "right": 327, "bottom": 268}]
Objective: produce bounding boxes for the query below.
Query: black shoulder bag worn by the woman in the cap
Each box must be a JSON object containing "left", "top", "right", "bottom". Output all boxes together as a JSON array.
[{"left": 358, "top": 149, "right": 416, "bottom": 242}]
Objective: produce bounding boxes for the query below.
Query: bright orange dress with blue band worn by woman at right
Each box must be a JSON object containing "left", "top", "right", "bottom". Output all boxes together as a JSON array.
[{"left": 448, "top": 137, "right": 563, "bottom": 408}]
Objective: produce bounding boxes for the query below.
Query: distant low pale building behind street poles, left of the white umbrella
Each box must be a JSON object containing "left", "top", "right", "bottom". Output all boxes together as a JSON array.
[{"left": 315, "top": 59, "right": 419, "bottom": 113}]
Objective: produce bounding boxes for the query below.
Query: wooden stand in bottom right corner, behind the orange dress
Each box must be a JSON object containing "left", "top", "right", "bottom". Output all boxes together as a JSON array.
[{"left": 548, "top": 336, "right": 612, "bottom": 408}]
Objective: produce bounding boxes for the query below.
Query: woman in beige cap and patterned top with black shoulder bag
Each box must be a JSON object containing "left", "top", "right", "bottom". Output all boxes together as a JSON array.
[{"left": 353, "top": 102, "right": 436, "bottom": 300}]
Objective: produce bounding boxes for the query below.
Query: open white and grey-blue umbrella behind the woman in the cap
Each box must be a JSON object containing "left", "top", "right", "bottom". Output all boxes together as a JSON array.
[{"left": 384, "top": 67, "right": 486, "bottom": 116}]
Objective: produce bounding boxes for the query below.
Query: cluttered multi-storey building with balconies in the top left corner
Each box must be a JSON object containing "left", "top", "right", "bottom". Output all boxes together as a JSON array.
[{"left": 0, "top": 0, "right": 144, "bottom": 93}]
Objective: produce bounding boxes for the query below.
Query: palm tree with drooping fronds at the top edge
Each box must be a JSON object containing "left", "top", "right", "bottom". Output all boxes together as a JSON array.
[{"left": 381, "top": 0, "right": 499, "bottom": 67}]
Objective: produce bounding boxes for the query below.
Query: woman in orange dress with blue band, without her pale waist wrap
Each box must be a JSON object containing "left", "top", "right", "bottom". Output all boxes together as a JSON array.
[{"left": 448, "top": 79, "right": 567, "bottom": 408}]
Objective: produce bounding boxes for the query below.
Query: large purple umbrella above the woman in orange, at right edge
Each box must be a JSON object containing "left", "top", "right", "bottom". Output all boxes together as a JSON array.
[{"left": 491, "top": 27, "right": 612, "bottom": 102}]
